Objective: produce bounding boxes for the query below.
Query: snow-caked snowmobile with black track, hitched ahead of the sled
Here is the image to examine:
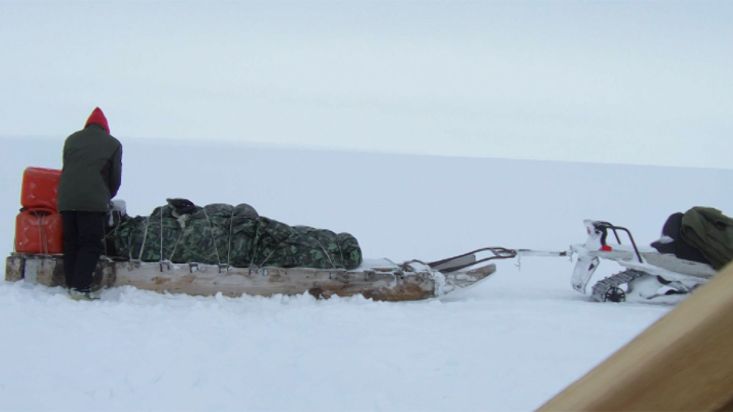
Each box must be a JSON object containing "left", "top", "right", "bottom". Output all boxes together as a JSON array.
[{"left": 570, "top": 220, "right": 716, "bottom": 303}]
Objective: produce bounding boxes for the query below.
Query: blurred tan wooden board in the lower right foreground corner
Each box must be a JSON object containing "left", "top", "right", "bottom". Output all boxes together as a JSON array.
[{"left": 540, "top": 264, "right": 733, "bottom": 411}]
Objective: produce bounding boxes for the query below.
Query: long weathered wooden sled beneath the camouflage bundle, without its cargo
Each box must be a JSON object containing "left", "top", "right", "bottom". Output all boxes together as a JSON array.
[{"left": 5, "top": 253, "right": 496, "bottom": 301}]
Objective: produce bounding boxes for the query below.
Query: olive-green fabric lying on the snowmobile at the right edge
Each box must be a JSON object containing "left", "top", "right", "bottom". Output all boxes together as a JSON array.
[{"left": 680, "top": 206, "right": 733, "bottom": 270}]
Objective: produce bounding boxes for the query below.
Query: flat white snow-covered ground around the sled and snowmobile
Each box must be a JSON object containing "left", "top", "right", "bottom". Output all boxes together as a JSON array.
[{"left": 0, "top": 136, "right": 733, "bottom": 411}]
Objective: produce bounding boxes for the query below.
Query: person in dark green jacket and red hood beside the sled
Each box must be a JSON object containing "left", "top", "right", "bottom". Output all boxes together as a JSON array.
[{"left": 58, "top": 107, "right": 122, "bottom": 299}]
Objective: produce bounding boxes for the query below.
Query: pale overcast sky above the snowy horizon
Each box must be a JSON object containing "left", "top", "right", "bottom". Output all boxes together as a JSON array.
[{"left": 0, "top": 1, "right": 733, "bottom": 169}]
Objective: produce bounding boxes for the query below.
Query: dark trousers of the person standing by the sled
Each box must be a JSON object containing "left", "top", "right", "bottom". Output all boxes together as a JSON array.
[{"left": 61, "top": 212, "right": 106, "bottom": 291}]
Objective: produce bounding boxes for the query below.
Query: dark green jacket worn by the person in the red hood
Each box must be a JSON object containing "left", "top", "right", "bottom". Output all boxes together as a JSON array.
[{"left": 58, "top": 123, "right": 122, "bottom": 212}]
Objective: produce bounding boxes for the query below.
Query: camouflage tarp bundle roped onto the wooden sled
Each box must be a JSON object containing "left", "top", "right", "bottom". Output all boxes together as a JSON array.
[{"left": 108, "top": 199, "right": 361, "bottom": 269}]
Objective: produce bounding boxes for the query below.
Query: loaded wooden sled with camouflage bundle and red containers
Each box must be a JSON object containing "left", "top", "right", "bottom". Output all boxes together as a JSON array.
[{"left": 5, "top": 168, "right": 501, "bottom": 301}]
